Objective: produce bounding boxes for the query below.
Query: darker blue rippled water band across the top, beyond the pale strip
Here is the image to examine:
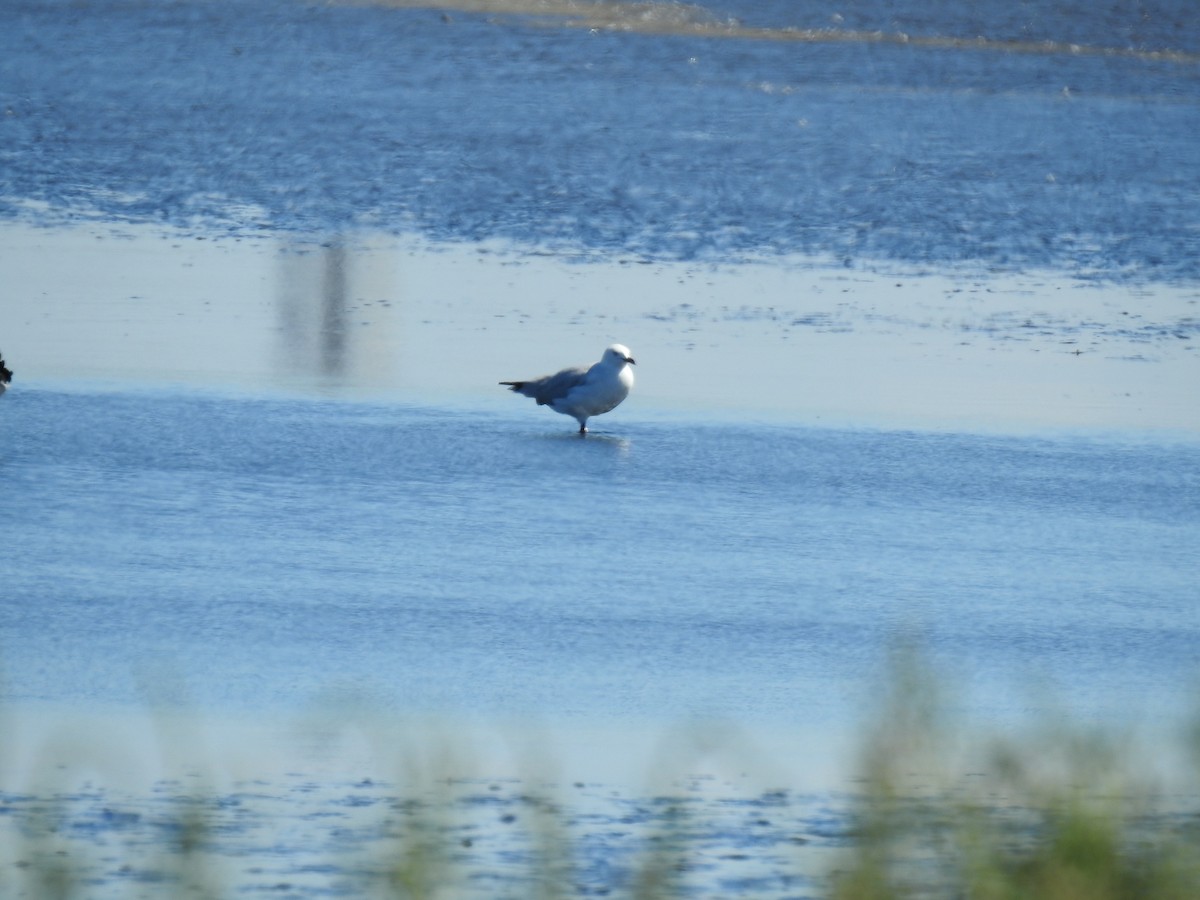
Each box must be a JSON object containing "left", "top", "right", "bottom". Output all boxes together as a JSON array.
[{"left": 0, "top": 0, "right": 1200, "bottom": 281}]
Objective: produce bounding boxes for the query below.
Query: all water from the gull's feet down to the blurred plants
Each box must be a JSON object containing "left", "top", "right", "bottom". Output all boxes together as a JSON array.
[{"left": 0, "top": 367, "right": 1200, "bottom": 896}]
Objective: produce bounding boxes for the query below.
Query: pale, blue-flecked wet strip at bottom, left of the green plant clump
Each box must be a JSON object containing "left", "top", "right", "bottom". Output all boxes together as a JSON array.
[{"left": 0, "top": 707, "right": 852, "bottom": 898}]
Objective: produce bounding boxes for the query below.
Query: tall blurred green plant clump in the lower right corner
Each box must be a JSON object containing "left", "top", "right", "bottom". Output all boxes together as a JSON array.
[{"left": 828, "top": 655, "right": 1200, "bottom": 900}]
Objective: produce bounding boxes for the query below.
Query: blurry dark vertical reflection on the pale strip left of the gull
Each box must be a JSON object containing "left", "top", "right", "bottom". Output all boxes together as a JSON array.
[{"left": 277, "top": 239, "right": 396, "bottom": 388}]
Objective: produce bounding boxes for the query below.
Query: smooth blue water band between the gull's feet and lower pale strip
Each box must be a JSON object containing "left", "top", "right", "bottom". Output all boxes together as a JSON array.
[{"left": 0, "top": 390, "right": 1200, "bottom": 726}]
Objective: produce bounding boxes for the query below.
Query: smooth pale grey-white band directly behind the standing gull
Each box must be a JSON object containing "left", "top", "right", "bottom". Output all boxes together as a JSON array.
[{"left": 9, "top": 223, "right": 1200, "bottom": 434}]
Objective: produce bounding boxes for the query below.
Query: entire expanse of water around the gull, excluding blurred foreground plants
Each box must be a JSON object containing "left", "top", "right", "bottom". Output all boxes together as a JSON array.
[{"left": 0, "top": 0, "right": 1200, "bottom": 896}]
